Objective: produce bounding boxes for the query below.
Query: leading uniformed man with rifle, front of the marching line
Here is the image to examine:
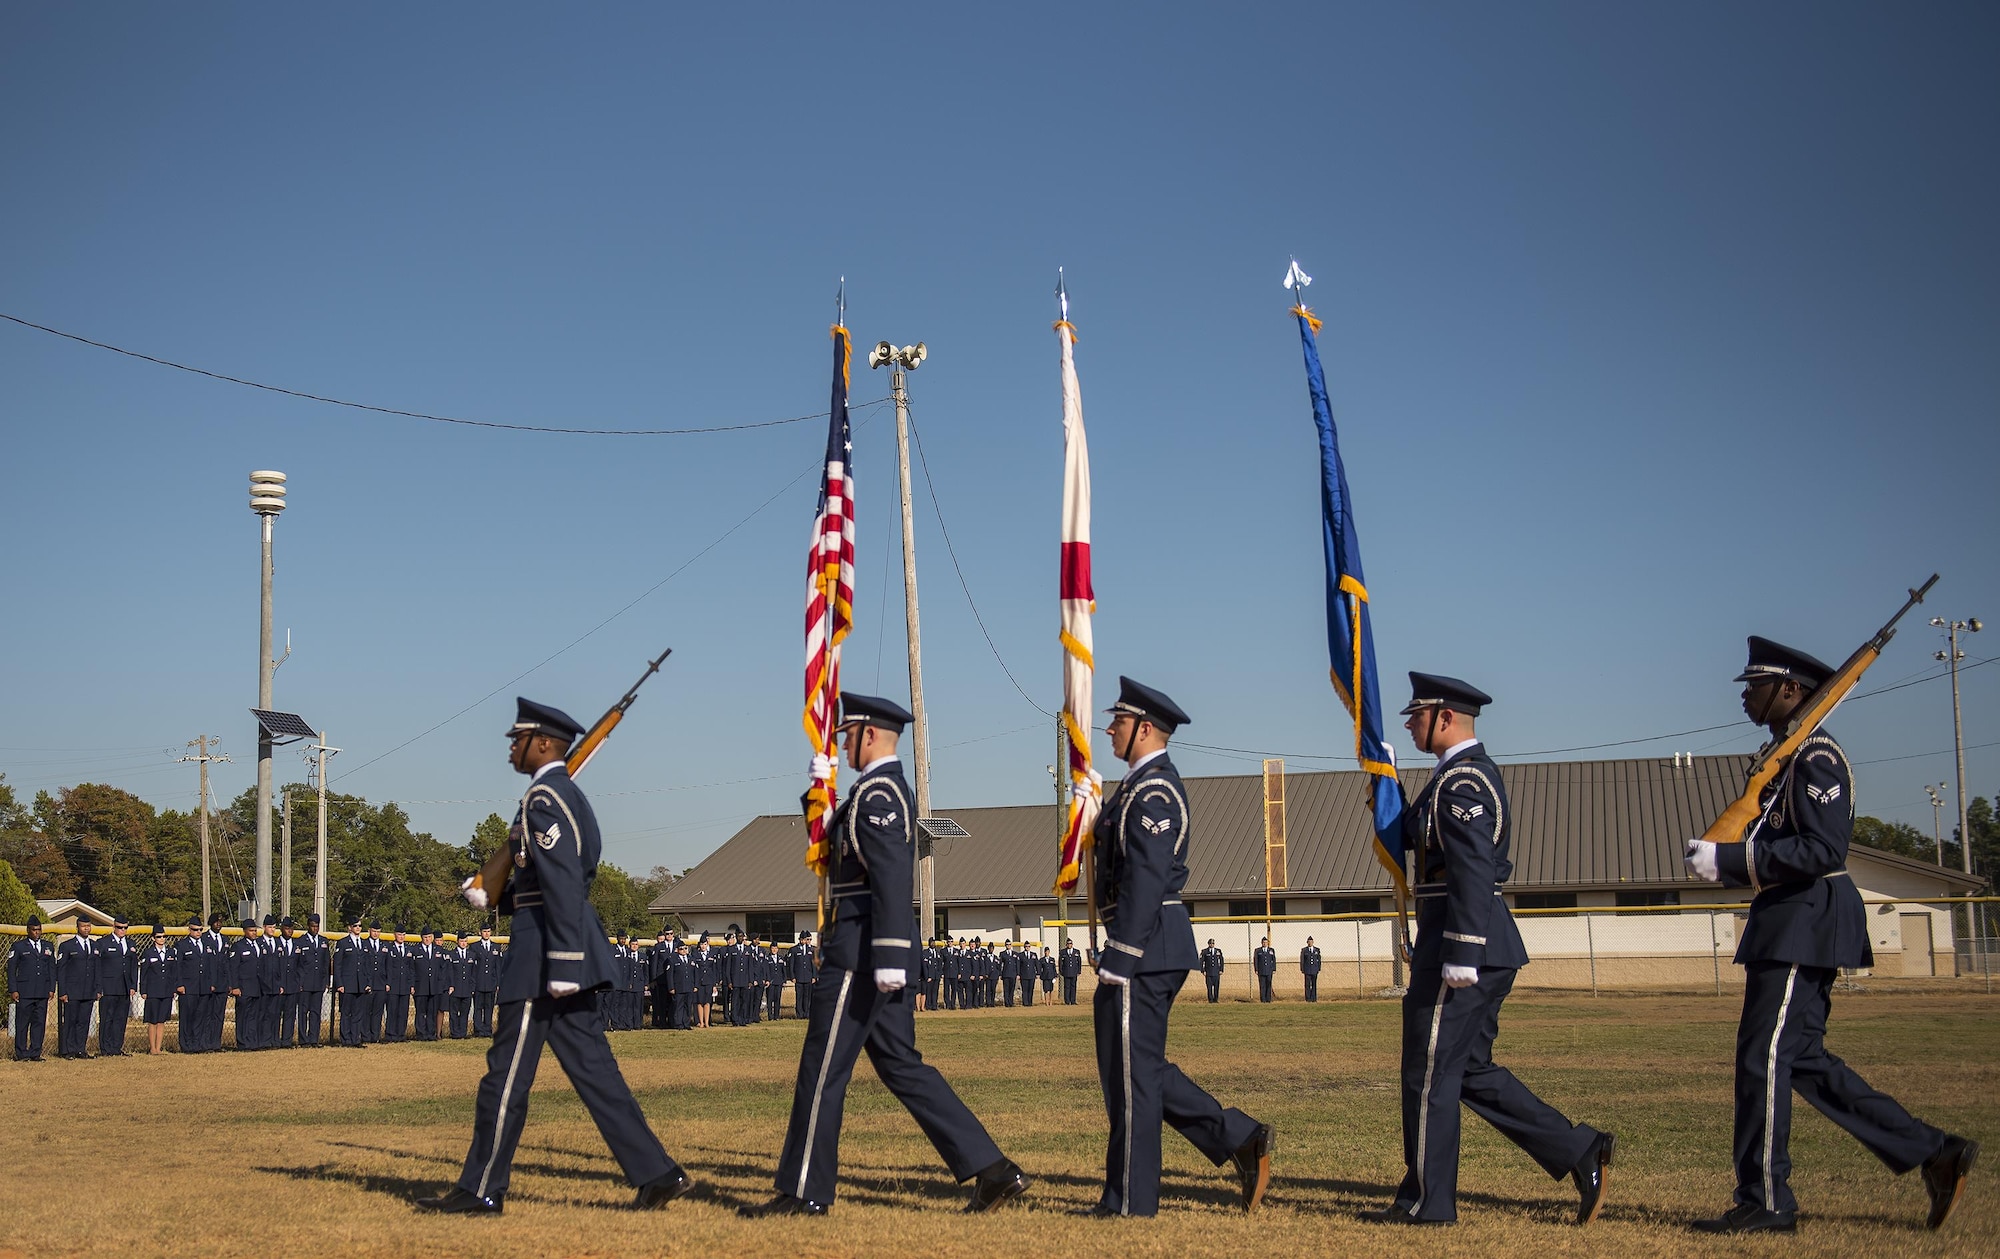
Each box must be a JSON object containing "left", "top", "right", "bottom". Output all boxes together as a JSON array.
[{"left": 416, "top": 699, "right": 694, "bottom": 1215}]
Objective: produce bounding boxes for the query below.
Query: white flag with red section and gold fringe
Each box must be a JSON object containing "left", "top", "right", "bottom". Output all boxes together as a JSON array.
[{"left": 1056, "top": 282, "right": 1104, "bottom": 895}]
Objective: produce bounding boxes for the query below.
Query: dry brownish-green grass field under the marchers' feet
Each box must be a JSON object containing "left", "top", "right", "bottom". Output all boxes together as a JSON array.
[{"left": 0, "top": 991, "right": 2000, "bottom": 1259}]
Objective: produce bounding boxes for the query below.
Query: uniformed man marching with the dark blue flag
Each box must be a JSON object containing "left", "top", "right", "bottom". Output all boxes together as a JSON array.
[{"left": 1366, "top": 673, "right": 1614, "bottom": 1225}]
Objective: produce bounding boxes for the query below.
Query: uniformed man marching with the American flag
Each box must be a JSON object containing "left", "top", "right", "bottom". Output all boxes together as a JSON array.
[{"left": 744, "top": 693, "right": 1028, "bottom": 1215}]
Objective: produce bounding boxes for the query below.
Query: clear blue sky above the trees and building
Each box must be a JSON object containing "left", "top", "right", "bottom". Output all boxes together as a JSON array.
[{"left": 0, "top": 4, "right": 2000, "bottom": 869}]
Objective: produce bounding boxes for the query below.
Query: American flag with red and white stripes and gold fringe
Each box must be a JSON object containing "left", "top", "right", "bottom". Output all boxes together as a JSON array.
[{"left": 804, "top": 324, "right": 854, "bottom": 875}]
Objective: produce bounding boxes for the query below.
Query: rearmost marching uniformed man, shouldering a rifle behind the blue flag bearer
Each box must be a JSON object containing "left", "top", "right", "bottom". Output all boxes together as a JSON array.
[{"left": 1686, "top": 637, "right": 1980, "bottom": 1233}]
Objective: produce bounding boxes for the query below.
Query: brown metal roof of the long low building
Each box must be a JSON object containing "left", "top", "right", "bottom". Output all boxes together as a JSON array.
[{"left": 652, "top": 755, "right": 1962, "bottom": 913}]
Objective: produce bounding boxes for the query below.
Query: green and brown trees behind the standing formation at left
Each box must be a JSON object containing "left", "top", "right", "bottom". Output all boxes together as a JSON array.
[{"left": 0, "top": 775, "right": 674, "bottom": 933}]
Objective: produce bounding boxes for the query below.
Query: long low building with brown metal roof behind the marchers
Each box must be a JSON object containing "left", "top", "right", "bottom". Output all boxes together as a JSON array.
[{"left": 650, "top": 755, "right": 1982, "bottom": 991}]
